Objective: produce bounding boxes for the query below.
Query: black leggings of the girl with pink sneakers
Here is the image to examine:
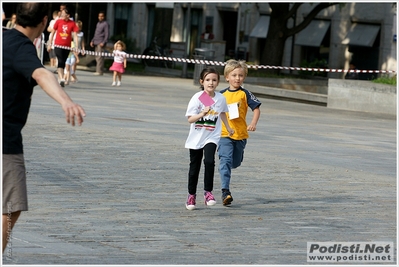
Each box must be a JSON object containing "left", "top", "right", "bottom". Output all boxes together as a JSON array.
[{"left": 188, "top": 143, "right": 216, "bottom": 195}]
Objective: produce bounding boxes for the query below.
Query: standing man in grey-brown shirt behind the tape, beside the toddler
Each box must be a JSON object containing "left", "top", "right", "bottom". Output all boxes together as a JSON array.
[{"left": 90, "top": 11, "right": 109, "bottom": 75}]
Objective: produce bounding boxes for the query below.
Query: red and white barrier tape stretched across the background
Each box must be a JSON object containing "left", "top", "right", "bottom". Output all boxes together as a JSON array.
[{"left": 54, "top": 45, "right": 396, "bottom": 74}]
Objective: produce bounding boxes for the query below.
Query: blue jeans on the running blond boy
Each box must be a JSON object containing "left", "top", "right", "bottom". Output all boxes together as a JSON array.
[{"left": 218, "top": 137, "right": 247, "bottom": 190}]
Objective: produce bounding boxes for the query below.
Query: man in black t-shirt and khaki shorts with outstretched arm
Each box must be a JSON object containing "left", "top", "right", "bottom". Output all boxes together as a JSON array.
[{"left": 2, "top": 2, "right": 86, "bottom": 252}]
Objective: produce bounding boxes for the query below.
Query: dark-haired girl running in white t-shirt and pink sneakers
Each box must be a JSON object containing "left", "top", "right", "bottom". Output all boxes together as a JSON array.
[{"left": 185, "top": 68, "right": 234, "bottom": 210}]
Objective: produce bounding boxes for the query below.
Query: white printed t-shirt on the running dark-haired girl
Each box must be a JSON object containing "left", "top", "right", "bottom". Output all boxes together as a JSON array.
[{"left": 185, "top": 91, "right": 229, "bottom": 149}]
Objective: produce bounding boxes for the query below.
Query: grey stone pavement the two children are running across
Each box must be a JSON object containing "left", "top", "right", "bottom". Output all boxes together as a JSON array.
[{"left": 3, "top": 71, "right": 397, "bottom": 265}]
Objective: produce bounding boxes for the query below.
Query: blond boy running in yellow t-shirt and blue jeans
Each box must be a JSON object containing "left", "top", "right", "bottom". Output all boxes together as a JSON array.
[{"left": 218, "top": 59, "right": 261, "bottom": 206}]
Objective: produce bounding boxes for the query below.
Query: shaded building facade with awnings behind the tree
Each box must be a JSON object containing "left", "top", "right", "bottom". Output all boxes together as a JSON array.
[{"left": 3, "top": 2, "right": 397, "bottom": 79}]
